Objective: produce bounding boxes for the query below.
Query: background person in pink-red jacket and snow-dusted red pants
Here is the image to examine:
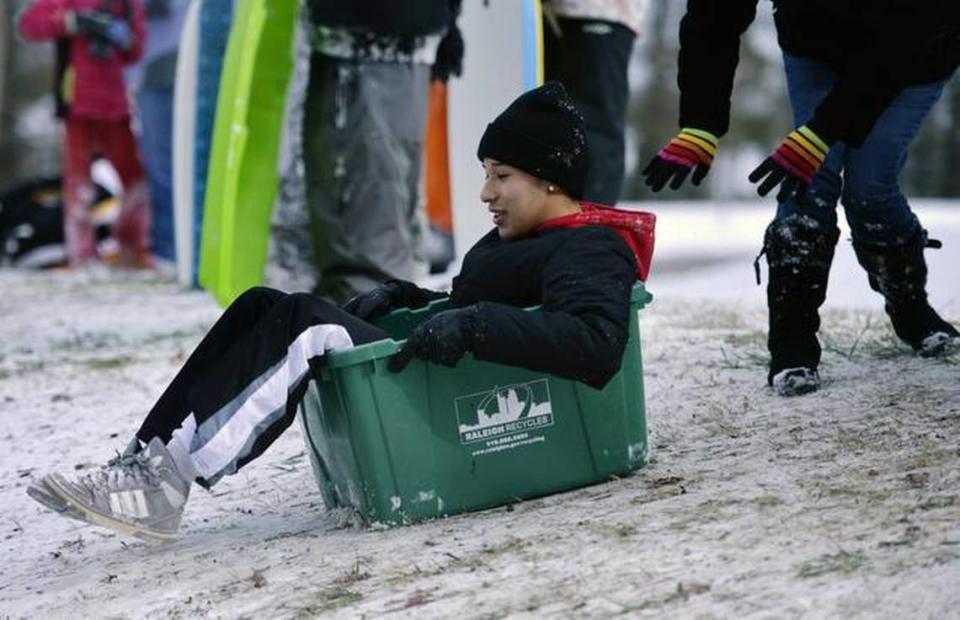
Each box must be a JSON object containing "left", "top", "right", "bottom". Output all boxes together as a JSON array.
[{"left": 19, "top": 0, "right": 153, "bottom": 268}]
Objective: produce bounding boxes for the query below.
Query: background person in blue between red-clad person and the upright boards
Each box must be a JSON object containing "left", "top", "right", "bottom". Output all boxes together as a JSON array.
[{"left": 127, "top": 0, "right": 190, "bottom": 263}]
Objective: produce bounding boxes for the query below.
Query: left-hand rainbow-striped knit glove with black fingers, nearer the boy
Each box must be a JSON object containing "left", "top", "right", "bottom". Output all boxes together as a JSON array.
[{"left": 643, "top": 127, "right": 717, "bottom": 192}]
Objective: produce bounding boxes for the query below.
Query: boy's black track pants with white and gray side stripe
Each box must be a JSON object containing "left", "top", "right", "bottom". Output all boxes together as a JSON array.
[{"left": 137, "top": 288, "right": 387, "bottom": 486}]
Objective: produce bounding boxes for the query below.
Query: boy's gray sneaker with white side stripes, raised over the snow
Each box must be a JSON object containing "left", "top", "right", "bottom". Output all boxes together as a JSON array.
[{"left": 43, "top": 438, "right": 190, "bottom": 541}]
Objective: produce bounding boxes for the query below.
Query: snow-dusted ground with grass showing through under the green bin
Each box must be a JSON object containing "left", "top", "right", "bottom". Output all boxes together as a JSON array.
[{"left": 0, "top": 202, "right": 960, "bottom": 618}]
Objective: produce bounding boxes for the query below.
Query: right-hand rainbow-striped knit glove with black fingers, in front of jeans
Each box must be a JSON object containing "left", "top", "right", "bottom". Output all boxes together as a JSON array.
[{"left": 748, "top": 125, "right": 830, "bottom": 202}]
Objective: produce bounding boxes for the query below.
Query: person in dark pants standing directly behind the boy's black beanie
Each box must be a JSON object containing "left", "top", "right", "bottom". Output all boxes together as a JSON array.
[{"left": 543, "top": 0, "right": 646, "bottom": 205}]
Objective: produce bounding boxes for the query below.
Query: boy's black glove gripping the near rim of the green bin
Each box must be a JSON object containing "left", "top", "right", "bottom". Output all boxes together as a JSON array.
[{"left": 387, "top": 306, "right": 477, "bottom": 372}]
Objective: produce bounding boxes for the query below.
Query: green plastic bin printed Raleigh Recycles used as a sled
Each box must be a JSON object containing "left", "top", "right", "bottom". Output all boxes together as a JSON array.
[{"left": 300, "top": 283, "right": 652, "bottom": 524}]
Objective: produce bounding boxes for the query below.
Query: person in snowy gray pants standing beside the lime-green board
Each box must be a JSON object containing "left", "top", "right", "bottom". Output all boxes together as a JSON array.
[{"left": 303, "top": 0, "right": 463, "bottom": 303}]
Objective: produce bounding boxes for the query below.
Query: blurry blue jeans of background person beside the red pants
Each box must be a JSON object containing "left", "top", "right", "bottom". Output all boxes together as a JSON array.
[{"left": 137, "top": 88, "right": 176, "bottom": 261}]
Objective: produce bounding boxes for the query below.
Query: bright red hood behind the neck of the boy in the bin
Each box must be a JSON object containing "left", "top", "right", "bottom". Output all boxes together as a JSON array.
[{"left": 537, "top": 202, "right": 657, "bottom": 282}]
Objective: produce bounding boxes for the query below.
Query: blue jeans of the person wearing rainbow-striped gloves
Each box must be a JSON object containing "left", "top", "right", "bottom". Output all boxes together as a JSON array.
[{"left": 777, "top": 53, "right": 946, "bottom": 245}]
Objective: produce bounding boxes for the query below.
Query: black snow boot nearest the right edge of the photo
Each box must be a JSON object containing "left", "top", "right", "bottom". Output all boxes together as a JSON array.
[{"left": 853, "top": 226, "right": 960, "bottom": 357}]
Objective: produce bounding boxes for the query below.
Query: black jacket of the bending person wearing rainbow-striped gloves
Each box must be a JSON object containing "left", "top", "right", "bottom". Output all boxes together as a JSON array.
[{"left": 677, "top": 0, "right": 960, "bottom": 146}]
